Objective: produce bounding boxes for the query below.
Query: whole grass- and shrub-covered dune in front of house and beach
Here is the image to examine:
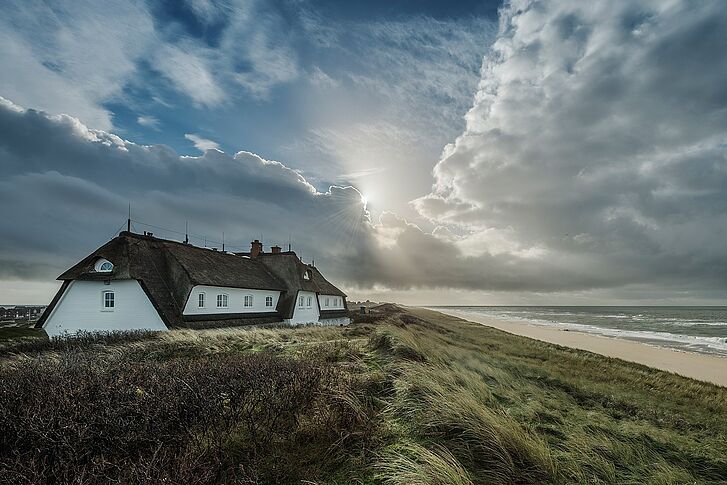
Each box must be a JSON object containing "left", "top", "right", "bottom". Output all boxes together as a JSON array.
[{"left": 0, "top": 308, "right": 727, "bottom": 484}]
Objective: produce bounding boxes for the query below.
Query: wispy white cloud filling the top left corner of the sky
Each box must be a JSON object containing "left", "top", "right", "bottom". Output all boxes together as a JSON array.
[{"left": 0, "top": 1, "right": 154, "bottom": 130}]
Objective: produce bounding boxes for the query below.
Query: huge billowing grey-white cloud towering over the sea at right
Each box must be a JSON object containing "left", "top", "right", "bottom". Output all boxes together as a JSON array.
[{"left": 414, "top": 0, "right": 727, "bottom": 291}]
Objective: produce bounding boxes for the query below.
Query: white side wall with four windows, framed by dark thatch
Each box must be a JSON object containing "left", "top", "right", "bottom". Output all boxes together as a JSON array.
[{"left": 184, "top": 285, "right": 280, "bottom": 315}]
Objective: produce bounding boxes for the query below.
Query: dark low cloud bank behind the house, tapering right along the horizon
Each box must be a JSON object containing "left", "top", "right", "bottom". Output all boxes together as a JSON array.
[{"left": 0, "top": 94, "right": 624, "bottom": 289}]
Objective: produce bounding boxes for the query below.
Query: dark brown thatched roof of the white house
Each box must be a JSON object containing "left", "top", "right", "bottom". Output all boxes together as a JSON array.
[{"left": 37, "top": 232, "right": 345, "bottom": 327}]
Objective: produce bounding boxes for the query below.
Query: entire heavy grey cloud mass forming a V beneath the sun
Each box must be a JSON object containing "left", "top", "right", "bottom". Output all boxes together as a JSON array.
[{"left": 0, "top": 0, "right": 727, "bottom": 295}]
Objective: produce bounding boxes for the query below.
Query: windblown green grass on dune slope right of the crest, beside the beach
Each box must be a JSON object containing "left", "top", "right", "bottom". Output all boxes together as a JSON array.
[{"left": 378, "top": 310, "right": 727, "bottom": 483}]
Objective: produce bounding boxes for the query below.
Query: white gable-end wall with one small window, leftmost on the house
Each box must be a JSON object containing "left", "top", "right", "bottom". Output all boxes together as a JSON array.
[{"left": 43, "top": 280, "right": 167, "bottom": 337}]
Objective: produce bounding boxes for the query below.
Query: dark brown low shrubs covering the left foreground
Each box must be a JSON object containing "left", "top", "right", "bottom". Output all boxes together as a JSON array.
[{"left": 0, "top": 351, "right": 351, "bottom": 483}]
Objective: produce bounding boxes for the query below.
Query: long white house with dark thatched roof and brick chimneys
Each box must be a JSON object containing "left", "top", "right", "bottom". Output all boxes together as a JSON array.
[{"left": 36, "top": 231, "right": 349, "bottom": 336}]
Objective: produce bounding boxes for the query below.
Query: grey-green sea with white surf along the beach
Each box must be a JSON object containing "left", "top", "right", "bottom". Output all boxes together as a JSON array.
[{"left": 431, "top": 306, "right": 727, "bottom": 357}]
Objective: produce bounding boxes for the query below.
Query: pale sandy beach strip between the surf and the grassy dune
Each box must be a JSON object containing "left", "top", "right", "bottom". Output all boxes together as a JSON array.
[{"left": 430, "top": 307, "right": 727, "bottom": 387}]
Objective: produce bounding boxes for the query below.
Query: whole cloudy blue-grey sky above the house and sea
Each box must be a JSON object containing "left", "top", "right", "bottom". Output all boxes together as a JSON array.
[{"left": 0, "top": 0, "right": 727, "bottom": 304}]
